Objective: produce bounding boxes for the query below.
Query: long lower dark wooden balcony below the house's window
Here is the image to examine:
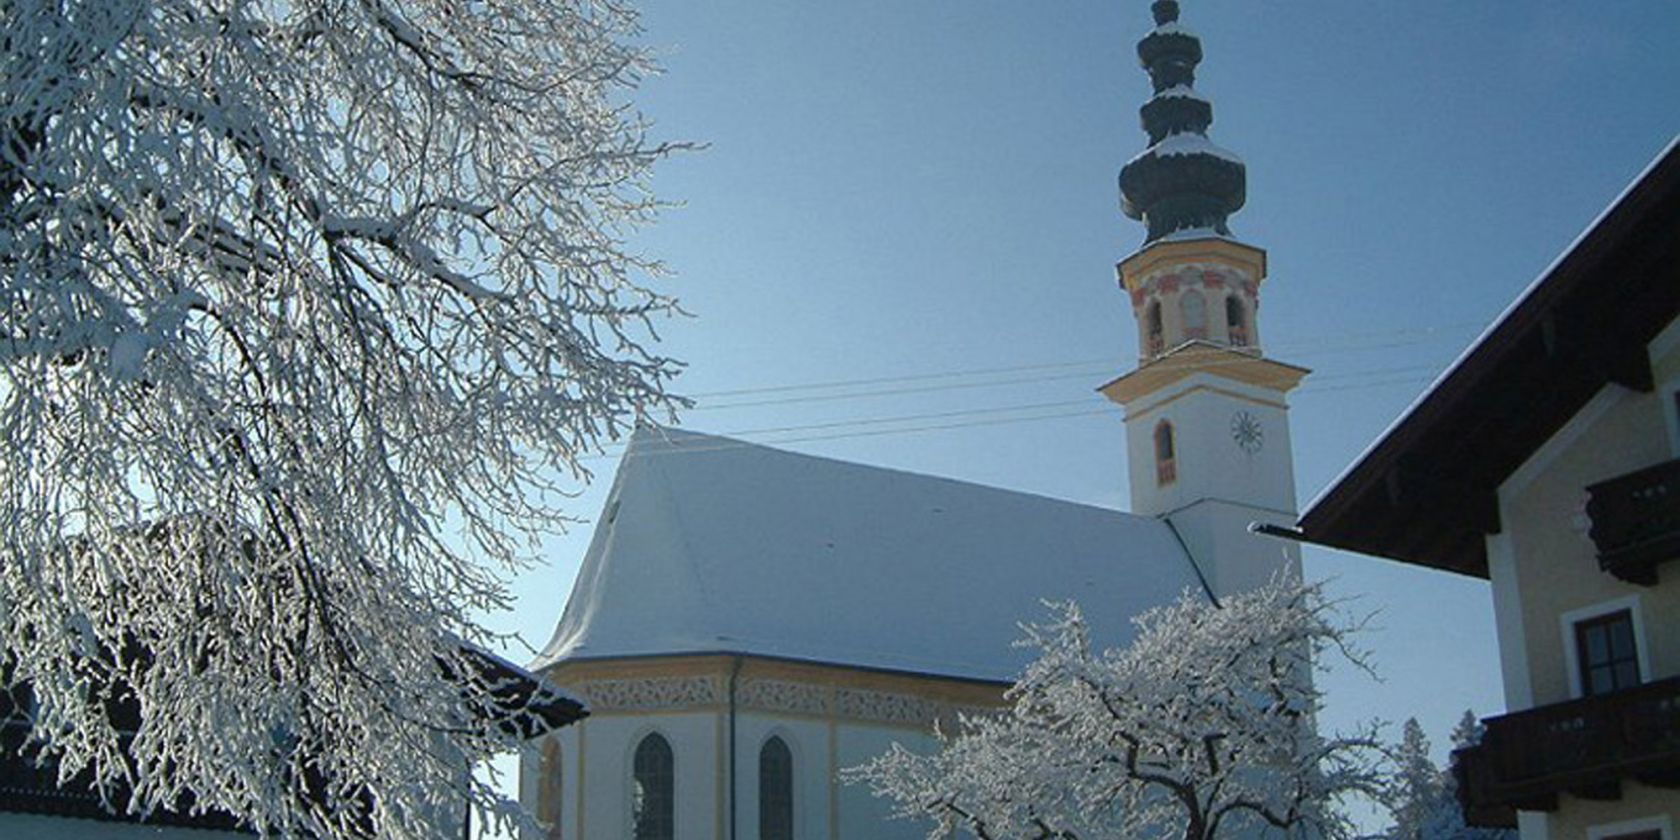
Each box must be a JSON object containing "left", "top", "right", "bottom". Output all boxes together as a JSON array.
[{"left": 1453, "top": 677, "right": 1680, "bottom": 827}]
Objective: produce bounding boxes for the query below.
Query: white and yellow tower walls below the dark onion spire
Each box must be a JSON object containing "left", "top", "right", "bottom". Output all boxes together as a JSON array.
[{"left": 1102, "top": 237, "right": 1307, "bottom": 596}]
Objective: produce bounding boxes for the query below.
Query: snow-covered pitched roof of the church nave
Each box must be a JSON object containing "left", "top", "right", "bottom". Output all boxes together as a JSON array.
[{"left": 536, "top": 427, "right": 1201, "bottom": 682}]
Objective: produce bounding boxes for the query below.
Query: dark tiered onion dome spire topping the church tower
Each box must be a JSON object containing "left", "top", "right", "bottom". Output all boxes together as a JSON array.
[{"left": 1121, "top": 0, "right": 1248, "bottom": 244}]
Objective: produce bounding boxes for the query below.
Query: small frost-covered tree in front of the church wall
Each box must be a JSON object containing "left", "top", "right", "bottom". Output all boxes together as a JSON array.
[{"left": 848, "top": 581, "right": 1386, "bottom": 840}]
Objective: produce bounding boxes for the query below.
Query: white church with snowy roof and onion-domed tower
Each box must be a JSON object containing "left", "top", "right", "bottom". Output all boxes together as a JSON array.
[{"left": 519, "top": 0, "right": 1307, "bottom": 840}]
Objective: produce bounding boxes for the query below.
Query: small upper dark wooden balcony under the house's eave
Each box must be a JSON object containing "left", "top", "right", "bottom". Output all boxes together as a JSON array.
[{"left": 1586, "top": 459, "right": 1680, "bottom": 586}]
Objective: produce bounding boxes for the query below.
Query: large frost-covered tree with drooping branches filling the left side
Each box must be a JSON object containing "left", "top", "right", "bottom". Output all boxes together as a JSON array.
[{"left": 0, "top": 0, "right": 677, "bottom": 837}]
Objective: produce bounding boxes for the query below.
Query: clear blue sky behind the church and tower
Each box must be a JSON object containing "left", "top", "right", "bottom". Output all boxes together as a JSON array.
[{"left": 494, "top": 0, "right": 1680, "bottom": 799}]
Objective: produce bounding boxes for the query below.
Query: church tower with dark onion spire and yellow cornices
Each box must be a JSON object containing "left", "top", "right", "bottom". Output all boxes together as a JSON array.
[{"left": 1100, "top": 0, "right": 1307, "bottom": 596}]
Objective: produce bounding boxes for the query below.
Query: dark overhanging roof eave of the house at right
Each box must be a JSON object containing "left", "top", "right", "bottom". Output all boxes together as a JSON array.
[{"left": 1297, "top": 138, "right": 1680, "bottom": 578}]
